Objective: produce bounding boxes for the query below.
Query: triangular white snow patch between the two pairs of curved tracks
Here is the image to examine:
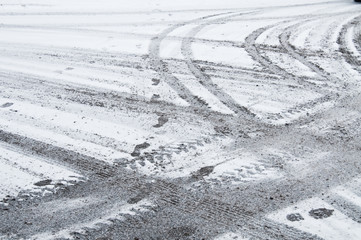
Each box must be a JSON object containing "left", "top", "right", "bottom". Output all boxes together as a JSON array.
[{"left": 213, "top": 78, "right": 326, "bottom": 124}]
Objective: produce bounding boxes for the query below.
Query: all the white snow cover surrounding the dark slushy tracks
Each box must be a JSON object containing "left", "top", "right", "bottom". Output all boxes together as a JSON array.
[{"left": 0, "top": 0, "right": 361, "bottom": 240}]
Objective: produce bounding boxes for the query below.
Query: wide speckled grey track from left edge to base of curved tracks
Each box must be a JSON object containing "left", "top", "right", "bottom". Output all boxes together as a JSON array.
[{"left": 0, "top": 71, "right": 225, "bottom": 122}]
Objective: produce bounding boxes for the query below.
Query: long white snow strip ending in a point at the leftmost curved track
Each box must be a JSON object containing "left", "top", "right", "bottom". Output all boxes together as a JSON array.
[{"left": 0, "top": 57, "right": 189, "bottom": 106}]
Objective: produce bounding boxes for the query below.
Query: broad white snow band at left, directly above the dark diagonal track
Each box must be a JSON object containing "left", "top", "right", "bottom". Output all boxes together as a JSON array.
[{"left": 0, "top": 98, "right": 208, "bottom": 163}]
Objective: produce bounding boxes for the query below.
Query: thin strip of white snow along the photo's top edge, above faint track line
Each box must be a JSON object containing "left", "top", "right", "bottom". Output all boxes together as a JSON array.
[{"left": 2, "top": 0, "right": 339, "bottom": 13}]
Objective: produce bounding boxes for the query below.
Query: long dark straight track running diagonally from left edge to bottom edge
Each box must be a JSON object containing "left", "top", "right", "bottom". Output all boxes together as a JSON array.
[{"left": 0, "top": 138, "right": 317, "bottom": 240}]
